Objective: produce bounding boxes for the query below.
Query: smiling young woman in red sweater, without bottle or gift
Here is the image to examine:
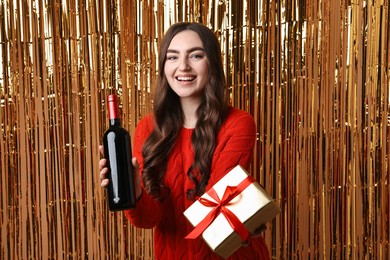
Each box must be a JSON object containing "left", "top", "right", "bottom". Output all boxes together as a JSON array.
[{"left": 99, "top": 23, "right": 269, "bottom": 259}]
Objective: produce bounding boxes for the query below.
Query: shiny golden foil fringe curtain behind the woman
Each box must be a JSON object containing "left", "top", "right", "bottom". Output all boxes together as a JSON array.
[{"left": 0, "top": 0, "right": 390, "bottom": 259}]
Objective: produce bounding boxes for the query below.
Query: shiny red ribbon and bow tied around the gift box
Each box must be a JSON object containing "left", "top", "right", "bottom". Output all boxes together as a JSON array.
[{"left": 186, "top": 176, "right": 254, "bottom": 241}]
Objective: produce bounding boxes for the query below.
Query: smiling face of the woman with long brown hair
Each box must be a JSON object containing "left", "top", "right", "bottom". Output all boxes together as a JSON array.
[{"left": 164, "top": 30, "right": 209, "bottom": 101}]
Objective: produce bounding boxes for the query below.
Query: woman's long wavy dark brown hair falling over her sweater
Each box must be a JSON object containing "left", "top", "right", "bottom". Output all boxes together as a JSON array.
[{"left": 142, "top": 22, "right": 228, "bottom": 199}]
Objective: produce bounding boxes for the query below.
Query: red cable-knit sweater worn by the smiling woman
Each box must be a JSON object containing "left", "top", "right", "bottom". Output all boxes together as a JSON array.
[{"left": 125, "top": 108, "right": 269, "bottom": 260}]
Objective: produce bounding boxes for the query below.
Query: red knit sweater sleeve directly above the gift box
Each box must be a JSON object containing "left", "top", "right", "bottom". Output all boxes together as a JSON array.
[{"left": 206, "top": 109, "right": 256, "bottom": 190}]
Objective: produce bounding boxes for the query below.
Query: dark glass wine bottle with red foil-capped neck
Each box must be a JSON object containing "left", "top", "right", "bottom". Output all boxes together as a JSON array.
[{"left": 103, "top": 95, "right": 136, "bottom": 211}]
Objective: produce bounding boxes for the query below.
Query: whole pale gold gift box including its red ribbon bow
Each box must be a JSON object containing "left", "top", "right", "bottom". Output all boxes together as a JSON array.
[{"left": 184, "top": 166, "right": 280, "bottom": 258}]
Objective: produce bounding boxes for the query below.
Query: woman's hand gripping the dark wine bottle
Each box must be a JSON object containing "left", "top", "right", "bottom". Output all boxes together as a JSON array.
[{"left": 99, "top": 145, "right": 142, "bottom": 200}]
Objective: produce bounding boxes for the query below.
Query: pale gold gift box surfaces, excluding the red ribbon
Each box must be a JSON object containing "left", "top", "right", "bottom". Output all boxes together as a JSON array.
[{"left": 184, "top": 166, "right": 280, "bottom": 258}]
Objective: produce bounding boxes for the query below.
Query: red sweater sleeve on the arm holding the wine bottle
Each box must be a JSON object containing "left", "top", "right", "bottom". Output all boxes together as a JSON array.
[{"left": 125, "top": 116, "right": 162, "bottom": 228}]
